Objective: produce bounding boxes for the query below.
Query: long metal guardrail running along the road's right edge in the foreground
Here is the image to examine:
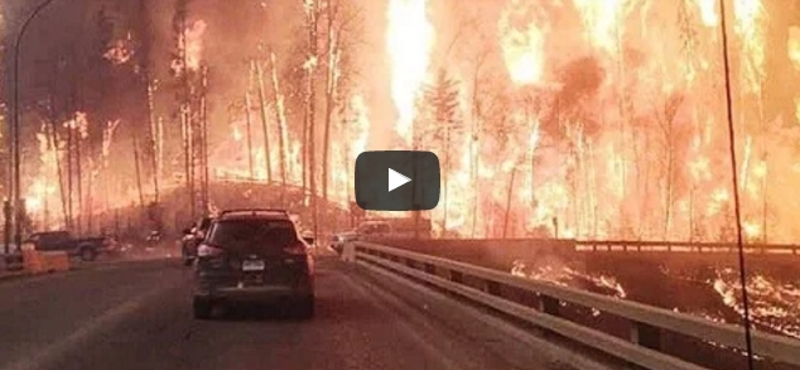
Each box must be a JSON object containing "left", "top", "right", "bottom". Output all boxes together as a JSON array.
[{"left": 353, "top": 241, "right": 800, "bottom": 370}]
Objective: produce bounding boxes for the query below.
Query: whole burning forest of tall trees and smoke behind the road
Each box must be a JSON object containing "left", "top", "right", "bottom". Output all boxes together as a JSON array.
[{"left": 0, "top": 0, "right": 800, "bottom": 243}]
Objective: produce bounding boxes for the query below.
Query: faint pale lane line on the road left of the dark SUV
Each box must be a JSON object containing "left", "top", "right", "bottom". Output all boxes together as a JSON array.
[{"left": 4, "top": 280, "right": 183, "bottom": 370}]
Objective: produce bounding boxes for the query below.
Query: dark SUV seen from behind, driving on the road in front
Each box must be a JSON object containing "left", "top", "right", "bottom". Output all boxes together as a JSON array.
[{"left": 194, "top": 209, "right": 314, "bottom": 319}]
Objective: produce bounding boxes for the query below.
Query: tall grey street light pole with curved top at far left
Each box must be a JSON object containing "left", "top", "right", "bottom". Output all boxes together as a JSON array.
[{"left": 11, "top": 0, "right": 61, "bottom": 248}]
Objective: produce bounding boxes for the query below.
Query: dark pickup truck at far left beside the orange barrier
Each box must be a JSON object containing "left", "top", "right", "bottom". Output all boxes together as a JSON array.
[{"left": 25, "top": 231, "right": 112, "bottom": 261}]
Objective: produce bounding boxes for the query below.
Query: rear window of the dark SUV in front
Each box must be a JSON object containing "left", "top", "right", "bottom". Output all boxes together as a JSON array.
[{"left": 206, "top": 220, "right": 298, "bottom": 249}]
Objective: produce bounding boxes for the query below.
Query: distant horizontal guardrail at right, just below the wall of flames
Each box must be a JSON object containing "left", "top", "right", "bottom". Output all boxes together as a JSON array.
[{"left": 575, "top": 240, "right": 800, "bottom": 256}]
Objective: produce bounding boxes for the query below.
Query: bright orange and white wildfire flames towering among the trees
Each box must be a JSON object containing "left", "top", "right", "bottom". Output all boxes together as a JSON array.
[{"left": 10, "top": 0, "right": 800, "bottom": 246}]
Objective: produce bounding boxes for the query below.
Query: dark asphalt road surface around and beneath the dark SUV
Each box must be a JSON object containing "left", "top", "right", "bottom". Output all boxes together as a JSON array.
[{"left": 0, "top": 254, "right": 604, "bottom": 370}]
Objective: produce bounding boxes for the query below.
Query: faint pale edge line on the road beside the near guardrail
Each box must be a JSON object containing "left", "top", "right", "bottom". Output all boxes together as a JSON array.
[{"left": 359, "top": 264, "right": 614, "bottom": 370}]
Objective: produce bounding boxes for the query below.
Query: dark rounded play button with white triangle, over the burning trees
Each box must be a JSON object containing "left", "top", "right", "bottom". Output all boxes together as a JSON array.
[{"left": 355, "top": 150, "right": 441, "bottom": 211}]
